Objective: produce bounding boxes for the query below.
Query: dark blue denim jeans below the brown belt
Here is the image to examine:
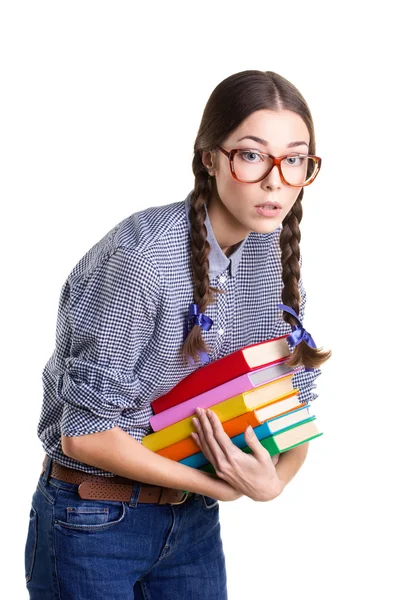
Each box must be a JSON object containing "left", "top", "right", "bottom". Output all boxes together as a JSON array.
[{"left": 25, "top": 460, "right": 228, "bottom": 600}]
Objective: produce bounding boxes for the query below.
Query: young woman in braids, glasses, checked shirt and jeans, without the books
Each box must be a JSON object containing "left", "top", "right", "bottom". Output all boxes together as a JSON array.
[{"left": 25, "top": 70, "right": 331, "bottom": 600}]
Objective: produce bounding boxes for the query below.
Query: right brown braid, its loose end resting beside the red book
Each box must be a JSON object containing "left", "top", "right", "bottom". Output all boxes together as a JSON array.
[{"left": 279, "top": 189, "right": 332, "bottom": 369}]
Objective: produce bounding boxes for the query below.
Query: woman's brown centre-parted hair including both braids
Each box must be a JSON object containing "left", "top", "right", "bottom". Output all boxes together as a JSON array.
[{"left": 180, "top": 70, "right": 332, "bottom": 369}]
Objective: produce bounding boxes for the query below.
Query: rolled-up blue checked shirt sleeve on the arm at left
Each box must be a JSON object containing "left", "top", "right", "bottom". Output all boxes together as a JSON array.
[{"left": 56, "top": 247, "right": 160, "bottom": 436}]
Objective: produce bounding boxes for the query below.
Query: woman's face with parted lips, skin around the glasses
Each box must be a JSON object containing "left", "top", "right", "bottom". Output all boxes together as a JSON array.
[{"left": 202, "top": 109, "right": 310, "bottom": 249}]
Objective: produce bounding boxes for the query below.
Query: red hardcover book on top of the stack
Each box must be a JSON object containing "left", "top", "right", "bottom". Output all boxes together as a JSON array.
[{"left": 151, "top": 335, "right": 290, "bottom": 415}]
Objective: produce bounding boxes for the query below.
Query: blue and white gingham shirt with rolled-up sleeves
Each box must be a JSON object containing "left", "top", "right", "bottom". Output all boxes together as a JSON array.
[{"left": 37, "top": 191, "right": 321, "bottom": 476}]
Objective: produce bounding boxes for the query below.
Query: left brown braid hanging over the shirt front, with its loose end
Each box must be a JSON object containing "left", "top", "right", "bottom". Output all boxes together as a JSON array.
[{"left": 180, "top": 162, "right": 226, "bottom": 361}]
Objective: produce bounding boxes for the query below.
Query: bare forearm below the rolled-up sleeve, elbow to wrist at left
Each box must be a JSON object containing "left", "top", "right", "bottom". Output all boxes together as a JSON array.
[{"left": 62, "top": 426, "right": 221, "bottom": 498}]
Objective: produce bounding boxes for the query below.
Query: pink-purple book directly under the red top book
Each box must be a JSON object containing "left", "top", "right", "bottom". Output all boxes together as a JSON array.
[{"left": 150, "top": 358, "right": 301, "bottom": 431}]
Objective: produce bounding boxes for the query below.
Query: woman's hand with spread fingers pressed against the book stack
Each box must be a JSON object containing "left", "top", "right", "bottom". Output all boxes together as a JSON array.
[{"left": 192, "top": 408, "right": 284, "bottom": 502}]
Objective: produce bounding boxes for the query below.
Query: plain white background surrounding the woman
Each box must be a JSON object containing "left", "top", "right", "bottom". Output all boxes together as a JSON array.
[{"left": 0, "top": 0, "right": 400, "bottom": 600}]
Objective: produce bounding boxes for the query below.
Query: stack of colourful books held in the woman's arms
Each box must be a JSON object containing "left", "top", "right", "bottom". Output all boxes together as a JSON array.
[{"left": 142, "top": 335, "right": 322, "bottom": 473}]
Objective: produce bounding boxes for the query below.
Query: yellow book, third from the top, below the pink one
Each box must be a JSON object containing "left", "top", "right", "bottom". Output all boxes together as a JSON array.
[{"left": 142, "top": 374, "right": 293, "bottom": 452}]
